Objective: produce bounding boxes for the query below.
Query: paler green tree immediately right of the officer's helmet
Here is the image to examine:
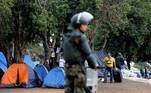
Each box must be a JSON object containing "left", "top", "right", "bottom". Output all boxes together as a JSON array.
[{"left": 95, "top": 0, "right": 129, "bottom": 50}]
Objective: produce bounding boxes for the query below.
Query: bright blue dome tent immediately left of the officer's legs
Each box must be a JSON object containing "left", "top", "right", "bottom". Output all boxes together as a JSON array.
[{"left": 43, "top": 67, "right": 65, "bottom": 88}]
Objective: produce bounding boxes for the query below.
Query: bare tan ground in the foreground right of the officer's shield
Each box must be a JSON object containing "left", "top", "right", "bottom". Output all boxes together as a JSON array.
[{"left": 99, "top": 80, "right": 151, "bottom": 93}]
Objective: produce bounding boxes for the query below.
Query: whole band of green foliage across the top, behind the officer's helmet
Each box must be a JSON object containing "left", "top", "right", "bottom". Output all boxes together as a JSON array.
[{"left": 0, "top": 0, "right": 151, "bottom": 59}]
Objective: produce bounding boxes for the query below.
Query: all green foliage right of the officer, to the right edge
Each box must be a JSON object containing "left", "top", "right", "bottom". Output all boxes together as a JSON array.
[{"left": 95, "top": 0, "right": 151, "bottom": 61}]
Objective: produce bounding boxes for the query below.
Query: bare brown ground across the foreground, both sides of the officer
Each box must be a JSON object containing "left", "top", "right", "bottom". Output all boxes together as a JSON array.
[{"left": 0, "top": 80, "right": 151, "bottom": 93}]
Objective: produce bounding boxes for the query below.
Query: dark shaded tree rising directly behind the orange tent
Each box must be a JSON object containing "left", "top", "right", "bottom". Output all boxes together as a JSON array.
[{"left": 11, "top": 0, "right": 35, "bottom": 62}]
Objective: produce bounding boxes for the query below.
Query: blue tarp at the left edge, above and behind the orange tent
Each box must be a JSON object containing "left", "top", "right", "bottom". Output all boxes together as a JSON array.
[{"left": 0, "top": 52, "right": 7, "bottom": 72}]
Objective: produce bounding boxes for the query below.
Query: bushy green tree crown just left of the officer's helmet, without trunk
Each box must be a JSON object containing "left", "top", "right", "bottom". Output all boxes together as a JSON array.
[{"left": 32, "top": 0, "right": 69, "bottom": 35}]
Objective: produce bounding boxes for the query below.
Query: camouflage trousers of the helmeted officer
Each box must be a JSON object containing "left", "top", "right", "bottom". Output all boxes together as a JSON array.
[{"left": 65, "top": 64, "right": 86, "bottom": 93}]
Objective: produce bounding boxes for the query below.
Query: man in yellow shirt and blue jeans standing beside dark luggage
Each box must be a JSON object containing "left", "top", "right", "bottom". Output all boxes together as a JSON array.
[{"left": 104, "top": 53, "right": 116, "bottom": 83}]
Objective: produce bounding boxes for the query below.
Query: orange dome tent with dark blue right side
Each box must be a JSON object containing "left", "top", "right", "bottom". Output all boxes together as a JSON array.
[{"left": 0, "top": 63, "right": 38, "bottom": 88}]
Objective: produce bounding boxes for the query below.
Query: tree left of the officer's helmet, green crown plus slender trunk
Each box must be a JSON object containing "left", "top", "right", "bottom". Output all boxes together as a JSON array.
[{"left": 32, "top": 0, "right": 68, "bottom": 68}]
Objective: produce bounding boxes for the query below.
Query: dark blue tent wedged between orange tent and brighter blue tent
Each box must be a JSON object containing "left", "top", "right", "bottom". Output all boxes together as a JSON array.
[{"left": 34, "top": 64, "right": 48, "bottom": 82}]
